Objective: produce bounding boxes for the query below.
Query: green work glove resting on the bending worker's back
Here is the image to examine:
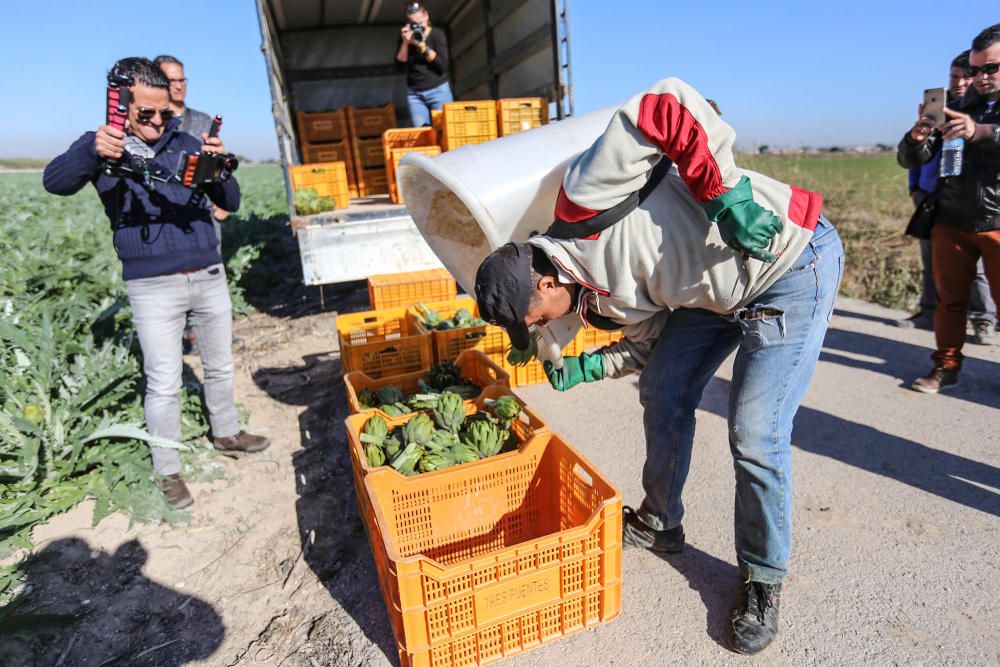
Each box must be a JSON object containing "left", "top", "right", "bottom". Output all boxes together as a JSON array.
[{"left": 702, "top": 176, "right": 784, "bottom": 262}]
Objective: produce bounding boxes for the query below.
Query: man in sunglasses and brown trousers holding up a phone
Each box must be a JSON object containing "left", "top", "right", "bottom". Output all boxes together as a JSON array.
[{"left": 897, "top": 23, "right": 1000, "bottom": 394}]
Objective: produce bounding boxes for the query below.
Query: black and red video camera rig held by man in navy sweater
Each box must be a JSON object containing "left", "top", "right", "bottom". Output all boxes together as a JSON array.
[{"left": 104, "top": 63, "right": 239, "bottom": 190}]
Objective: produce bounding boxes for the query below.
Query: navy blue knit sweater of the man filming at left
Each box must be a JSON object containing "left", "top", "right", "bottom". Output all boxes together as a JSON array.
[{"left": 42, "top": 118, "right": 240, "bottom": 280}]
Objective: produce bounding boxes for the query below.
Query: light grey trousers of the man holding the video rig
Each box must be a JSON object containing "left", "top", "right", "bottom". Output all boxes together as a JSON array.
[{"left": 125, "top": 264, "right": 240, "bottom": 475}]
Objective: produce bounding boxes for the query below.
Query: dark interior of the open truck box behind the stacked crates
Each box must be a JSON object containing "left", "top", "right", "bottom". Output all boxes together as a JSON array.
[{"left": 257, "top": 0, "right": 573, "bottom": 213}]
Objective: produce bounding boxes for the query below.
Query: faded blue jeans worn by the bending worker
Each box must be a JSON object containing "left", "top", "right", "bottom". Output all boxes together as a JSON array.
[{"left": 639, "top": 218, "right": 844, "bottom": 583}]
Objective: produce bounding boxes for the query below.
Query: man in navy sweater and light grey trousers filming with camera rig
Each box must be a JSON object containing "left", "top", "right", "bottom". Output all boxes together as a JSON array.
[{"left": 43, "top": 58, "right": 270, "bottom": 508}]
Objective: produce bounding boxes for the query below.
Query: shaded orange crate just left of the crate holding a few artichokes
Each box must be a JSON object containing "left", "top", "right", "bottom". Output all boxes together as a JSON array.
[{"left": 337, "top": 308, "right": 434, "bottom": 378}]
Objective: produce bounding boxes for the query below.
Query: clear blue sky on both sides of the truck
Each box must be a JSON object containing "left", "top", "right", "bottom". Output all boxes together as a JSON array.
[{"left": 0, "top": 0, "right": 1000, "bottom": 158}]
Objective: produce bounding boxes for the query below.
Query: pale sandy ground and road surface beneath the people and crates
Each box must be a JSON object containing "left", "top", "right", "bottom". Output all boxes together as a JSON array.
[{"left": 0, "top": 293, "right": 1000, "bottom": 667}]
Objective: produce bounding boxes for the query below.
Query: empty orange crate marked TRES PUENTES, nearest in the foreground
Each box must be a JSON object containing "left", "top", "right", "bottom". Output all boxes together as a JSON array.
[{"left": 364, "top": 433, "right": 622, "bottom": 667}]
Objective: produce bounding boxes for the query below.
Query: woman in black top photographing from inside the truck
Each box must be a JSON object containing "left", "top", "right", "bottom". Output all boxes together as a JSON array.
[{"left": 396, "top": 2, "right": 454, "bottom": 127}]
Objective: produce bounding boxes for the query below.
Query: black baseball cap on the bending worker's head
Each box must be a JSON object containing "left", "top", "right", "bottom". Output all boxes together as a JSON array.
[{"left": 476, "top": 243, "right": 533, "bottom": 350}]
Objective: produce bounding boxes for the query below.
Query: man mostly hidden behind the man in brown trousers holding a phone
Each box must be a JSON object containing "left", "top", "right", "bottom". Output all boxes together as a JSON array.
[{"left": 896, "top": 50, "right": 997, "bottom": 345}]
